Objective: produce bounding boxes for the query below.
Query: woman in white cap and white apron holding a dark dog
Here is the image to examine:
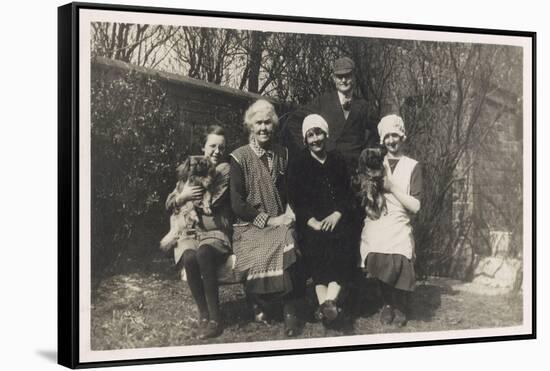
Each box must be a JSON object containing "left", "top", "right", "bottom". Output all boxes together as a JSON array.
[{"left": 360, "top": 115, "right": 422, "bottom": 327}]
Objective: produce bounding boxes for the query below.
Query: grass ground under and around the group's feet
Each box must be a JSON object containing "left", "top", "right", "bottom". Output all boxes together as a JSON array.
[{"left": 91, "top": 261, "right": 523, "bottom": 350}]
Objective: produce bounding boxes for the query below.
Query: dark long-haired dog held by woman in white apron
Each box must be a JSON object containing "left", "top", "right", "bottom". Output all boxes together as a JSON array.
[{"left": 354, "top": 147, "right": 387, "bottom": 220}]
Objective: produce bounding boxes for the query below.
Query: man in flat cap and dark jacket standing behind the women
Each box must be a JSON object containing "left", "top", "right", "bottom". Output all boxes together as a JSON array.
[{"left": 308, "top": 57, "right": 379, "bottom": 174}]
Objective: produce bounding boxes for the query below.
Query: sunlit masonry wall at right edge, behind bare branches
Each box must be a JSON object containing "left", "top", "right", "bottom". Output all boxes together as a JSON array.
[{"left": 451, "top": 90, "right": 523, "bottom": 279}]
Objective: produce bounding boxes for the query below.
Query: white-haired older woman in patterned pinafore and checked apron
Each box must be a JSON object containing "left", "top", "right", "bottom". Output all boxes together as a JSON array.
[{"left": 230, "top": 100, "right": 304, "bottom": 336}]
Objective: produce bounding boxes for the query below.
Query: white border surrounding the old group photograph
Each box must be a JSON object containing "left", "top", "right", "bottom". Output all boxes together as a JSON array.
[{"left": 70, "top": 4, "right": 535, "bottom": 363}]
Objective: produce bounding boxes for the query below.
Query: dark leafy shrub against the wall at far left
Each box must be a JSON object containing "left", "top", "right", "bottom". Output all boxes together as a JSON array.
[{"left": 91, "top": 70, "right": 183, "bottom": 275}]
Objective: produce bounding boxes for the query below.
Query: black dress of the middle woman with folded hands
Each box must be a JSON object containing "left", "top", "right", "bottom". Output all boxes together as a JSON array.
[{"left": 289, "top": 150, "right": 356, "bottom": 285}]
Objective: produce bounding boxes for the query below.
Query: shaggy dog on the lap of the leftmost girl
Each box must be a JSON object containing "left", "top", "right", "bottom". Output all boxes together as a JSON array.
[{"left": 160, "top": 156, "right": 216, "bottom": 251}]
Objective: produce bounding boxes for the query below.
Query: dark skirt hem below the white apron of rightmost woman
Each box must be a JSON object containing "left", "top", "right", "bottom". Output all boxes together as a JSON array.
[{"left": 365, "top": 253, "right": 416, "bottom": 291}]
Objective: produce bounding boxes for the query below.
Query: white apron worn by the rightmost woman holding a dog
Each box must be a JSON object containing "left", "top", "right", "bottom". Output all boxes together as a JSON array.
[{"left": 360, "top": 156, "right": 417, "bottom": 268}]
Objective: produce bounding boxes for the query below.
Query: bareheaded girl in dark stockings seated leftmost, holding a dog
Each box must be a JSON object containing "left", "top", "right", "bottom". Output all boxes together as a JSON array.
[{"left": 166, "top": 125, "right": 232, "bottom": 339}]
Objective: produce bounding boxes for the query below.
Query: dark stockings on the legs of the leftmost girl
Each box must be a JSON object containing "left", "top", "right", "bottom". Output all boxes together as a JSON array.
[{"left": 182, "top": 245, "right": 226, "bottom": 321}]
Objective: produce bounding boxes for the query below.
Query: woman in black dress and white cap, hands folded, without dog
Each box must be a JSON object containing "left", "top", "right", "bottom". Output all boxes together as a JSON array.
[{"left": 289, "top": 114, "right": 356, "bottom": 325}]
